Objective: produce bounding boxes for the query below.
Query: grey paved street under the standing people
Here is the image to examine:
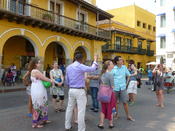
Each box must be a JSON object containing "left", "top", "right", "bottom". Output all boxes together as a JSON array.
[{"left": 0, "top": 82, "right": 175, "bottom": 131}]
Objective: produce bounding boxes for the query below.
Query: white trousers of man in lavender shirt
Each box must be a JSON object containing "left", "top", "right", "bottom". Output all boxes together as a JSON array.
[{"left": 65, "top": 89, "right": 87, "bottom": 131}]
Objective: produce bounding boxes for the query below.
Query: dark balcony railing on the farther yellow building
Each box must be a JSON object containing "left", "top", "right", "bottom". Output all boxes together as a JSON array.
[{"left": 102, "top": 44, "right": 146, "bottom": 55}]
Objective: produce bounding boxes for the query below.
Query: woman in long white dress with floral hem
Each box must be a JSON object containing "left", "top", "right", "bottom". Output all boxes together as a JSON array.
[{"left": 29, "top": 58, "right": 54, "bottom": 128}]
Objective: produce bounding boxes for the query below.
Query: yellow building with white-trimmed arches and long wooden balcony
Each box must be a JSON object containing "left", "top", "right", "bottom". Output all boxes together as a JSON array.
[{"left": 0, "top": 0, "right": 113, "bottom": 69}]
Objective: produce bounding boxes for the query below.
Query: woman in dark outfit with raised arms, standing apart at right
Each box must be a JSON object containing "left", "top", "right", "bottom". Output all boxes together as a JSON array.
[{"left": 153, "top": 64, "right": 164, "bottom": 108}]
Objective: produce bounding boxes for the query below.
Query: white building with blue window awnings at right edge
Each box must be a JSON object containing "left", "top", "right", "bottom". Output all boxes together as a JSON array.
[{"left": 156, "top": 0, "right": 175, "bottom": 70}]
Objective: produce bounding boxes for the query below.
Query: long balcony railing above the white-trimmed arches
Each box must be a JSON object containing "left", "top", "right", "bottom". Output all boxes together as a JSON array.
[{"left": 0, "top": 0, "right": 111, "bottom": 40}]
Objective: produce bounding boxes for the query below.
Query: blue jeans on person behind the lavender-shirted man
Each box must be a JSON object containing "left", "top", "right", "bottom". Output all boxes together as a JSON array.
[{"left": 90, "top": 87, "right": 98, "bottom": 109}]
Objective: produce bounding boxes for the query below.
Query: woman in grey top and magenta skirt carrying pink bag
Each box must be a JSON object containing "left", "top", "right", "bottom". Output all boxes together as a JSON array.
[{"left": 98, "top": 60, "right": 116, "bottom": 129}]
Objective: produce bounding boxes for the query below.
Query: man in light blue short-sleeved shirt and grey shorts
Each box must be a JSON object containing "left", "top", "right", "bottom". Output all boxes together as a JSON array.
[{"left": 112, "top": 56, "right": 135, "bottom": 121}]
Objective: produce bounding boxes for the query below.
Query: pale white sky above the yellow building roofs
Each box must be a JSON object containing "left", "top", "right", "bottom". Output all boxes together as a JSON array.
[{"left": 96, "top": 0, "right": 156, "bottom": 14}]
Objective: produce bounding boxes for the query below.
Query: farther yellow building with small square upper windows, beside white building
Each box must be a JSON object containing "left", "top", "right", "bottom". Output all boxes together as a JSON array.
[{"left": 99, "top": 5, "right": 156, "bottom": 68}]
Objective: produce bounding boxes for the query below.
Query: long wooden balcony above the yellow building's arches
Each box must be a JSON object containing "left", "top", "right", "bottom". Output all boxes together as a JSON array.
[{"left": 0, "top": 0, "right": 111, "bottom": 41}]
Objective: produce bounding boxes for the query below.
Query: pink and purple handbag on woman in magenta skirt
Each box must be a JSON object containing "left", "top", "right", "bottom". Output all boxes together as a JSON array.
[{"left": 97, "top": 85, "right": 112, "bottom": 103}]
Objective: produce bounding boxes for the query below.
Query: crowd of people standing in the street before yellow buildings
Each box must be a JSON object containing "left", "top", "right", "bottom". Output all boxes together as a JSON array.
[{"left": 23, "top": 53, "right": 174, "bottom": 131}]
